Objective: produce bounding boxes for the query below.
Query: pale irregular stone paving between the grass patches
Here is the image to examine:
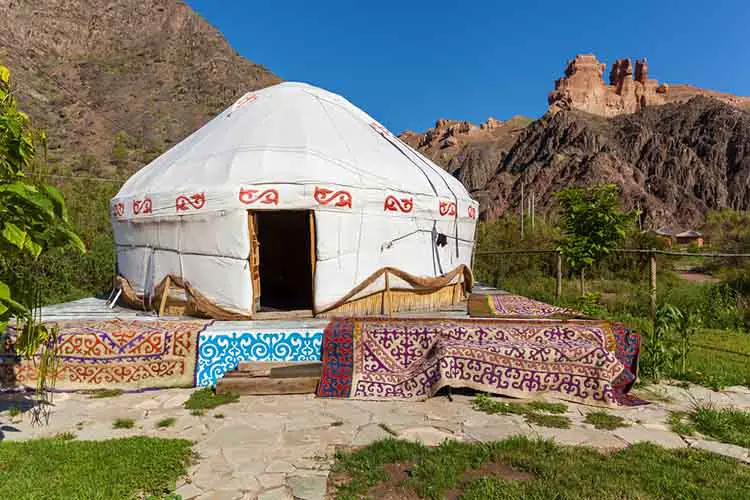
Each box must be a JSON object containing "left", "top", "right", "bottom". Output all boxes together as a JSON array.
[{"left": 0, "top": 385, "right": 750, "bottom": 500}]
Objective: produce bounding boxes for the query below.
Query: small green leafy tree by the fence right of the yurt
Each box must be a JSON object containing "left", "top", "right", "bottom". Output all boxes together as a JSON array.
[{"left": 557, "top": 184, "right": 636, "bottom": 296}]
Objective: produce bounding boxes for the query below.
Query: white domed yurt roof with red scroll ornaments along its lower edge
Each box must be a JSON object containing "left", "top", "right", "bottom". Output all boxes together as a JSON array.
[{"left": 112, "top": 82, "right": 476, "bottom": 219}]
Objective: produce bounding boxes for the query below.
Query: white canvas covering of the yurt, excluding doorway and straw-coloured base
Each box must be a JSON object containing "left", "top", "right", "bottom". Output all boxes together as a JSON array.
[{"left": 111, "top": 83, "right": 478, "bottom": 312}]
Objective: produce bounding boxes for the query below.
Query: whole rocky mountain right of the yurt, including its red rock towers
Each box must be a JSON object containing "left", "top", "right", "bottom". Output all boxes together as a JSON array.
[{"left": 401, "top": 55, "right": 750, "bottom": 227}]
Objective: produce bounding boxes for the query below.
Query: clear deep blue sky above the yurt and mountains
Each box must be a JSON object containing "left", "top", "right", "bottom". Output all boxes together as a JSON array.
[{"left": 187, "top": 0, "right": 750, "bottom": 133}]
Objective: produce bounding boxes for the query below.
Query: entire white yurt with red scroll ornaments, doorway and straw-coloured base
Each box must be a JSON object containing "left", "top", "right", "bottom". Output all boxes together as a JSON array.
[{"left": 111, "top": 83, "right": 478, "bottom": 319}]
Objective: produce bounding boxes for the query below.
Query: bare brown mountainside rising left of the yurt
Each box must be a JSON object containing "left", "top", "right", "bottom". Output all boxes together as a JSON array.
[{"left": 0, "top": 0, "right": 280, "bottom": 176}]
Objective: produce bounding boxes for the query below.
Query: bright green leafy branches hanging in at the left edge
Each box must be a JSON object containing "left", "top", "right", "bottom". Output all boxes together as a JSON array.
[{"left": 0, "top": 65, "right": 85, "bottom": 368}]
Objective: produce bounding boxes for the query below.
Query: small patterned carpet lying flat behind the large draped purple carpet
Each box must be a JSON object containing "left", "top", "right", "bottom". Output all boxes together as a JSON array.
[{"left": 469, "top": 294, "right": 583, "bottom": 319}]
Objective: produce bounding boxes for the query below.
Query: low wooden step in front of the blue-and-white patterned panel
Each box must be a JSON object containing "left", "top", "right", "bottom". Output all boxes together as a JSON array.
[{"left": 216, "top": 361, "right": 322, "bottom": 396}]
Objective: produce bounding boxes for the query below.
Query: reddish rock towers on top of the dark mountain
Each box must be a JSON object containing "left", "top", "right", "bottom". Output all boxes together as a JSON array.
[{"left": 548, "top": 54, "right": 668, "bottom": 116}]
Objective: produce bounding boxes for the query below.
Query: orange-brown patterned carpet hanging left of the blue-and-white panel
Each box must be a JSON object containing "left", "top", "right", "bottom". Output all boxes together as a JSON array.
[{"left": 0, "top": 319, "right": 210, "bottom": 390}]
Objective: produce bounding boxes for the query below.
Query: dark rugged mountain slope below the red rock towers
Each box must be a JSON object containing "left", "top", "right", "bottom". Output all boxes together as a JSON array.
[{"left": 412, "top": 97, "right": 750, "bottom": 226}]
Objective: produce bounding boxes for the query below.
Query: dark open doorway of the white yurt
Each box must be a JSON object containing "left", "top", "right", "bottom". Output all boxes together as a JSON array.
[{"left": 249, "top": 210, "right": 315, "bottom": 314}]
